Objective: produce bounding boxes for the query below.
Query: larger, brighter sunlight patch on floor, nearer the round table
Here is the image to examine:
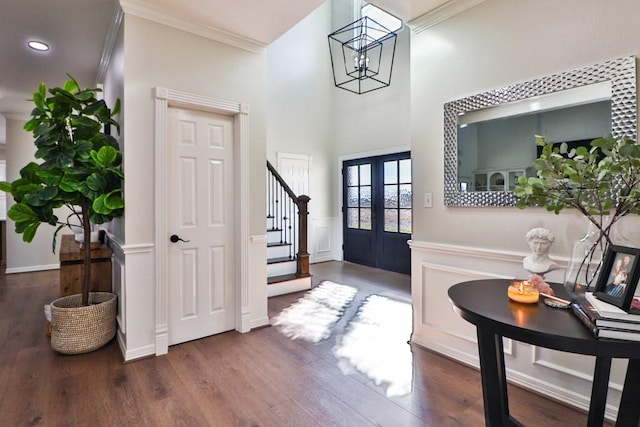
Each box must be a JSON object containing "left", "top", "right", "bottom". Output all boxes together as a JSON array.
[{"left": 333, "top": 295, "right": 413, "bottom": 397}]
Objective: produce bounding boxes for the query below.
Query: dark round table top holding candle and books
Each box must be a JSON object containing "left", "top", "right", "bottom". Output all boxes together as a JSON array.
[{"left": 448, "top": 279, "right": 640, "bottom": 359}]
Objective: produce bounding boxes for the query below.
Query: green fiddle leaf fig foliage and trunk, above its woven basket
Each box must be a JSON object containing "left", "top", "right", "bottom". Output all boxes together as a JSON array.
[{"left": 0, "top": 77, "right": 124, "bottom": 305}]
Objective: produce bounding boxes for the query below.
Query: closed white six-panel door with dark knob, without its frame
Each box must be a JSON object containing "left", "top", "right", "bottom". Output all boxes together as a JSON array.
[{"left": 167, "top": 108, "right": 235, "bottom": 345}]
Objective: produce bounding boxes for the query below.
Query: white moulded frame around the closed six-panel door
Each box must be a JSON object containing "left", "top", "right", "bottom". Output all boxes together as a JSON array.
[{"left": 153, "top": 87, "right": 251, "bottom": 355}]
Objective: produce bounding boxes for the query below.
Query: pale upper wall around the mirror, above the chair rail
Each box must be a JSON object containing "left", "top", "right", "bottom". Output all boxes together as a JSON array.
[{"left": 411, "top": 0, "right": 640, "bottom": 254}]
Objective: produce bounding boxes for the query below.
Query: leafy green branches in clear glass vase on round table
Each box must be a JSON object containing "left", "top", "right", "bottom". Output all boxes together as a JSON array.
[{"left": 515, "top": 136, "right": 640, "bottom": 291}]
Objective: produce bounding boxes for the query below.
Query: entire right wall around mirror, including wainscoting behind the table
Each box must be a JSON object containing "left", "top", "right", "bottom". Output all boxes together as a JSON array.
[{"left": 411, "top": 0, "right": 640, "bottom": 417}]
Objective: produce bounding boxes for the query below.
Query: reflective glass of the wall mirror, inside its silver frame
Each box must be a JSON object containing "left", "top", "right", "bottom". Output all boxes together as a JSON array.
[{"left": 458, "top": 88, "right": 611, "bottom": 191}]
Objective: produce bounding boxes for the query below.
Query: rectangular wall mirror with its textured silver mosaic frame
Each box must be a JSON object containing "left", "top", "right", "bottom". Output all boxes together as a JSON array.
[{"left": 444, "top": 56, "right": 637, "bottom": 206}]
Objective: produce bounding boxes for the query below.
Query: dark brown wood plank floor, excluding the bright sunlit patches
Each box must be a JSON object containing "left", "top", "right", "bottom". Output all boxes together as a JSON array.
[{"left": 0, "top": 262, "right": 604, "bottom": 427}]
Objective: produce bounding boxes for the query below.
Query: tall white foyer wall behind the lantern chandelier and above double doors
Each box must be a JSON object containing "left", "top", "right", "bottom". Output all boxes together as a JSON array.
[{"left": 267, "top": 0, "right": 410, "bottom": 262}]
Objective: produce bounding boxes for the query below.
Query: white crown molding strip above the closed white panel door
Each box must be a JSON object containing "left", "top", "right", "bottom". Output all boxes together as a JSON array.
[{"left": 120, "top": 0, "right": 267, "bottom": 53}]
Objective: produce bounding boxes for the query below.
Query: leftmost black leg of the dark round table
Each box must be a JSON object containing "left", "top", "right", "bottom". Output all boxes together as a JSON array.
[{"left": 477, "top": 328, "right": 520, "bottom": 427}]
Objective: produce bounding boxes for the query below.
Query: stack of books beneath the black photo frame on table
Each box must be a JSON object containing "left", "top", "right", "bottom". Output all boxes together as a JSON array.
[{"left": 571, "top": 292, "right": 640, "bottom": 341}]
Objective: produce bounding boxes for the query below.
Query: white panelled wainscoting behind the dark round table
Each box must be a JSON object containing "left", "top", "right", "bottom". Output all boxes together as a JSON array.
[{"left": 410, "top": 241, "right": 626, "bottom": 419}]
